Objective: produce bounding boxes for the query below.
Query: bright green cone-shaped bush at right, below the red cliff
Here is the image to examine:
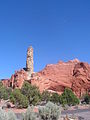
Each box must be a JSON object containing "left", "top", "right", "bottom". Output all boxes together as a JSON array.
[{"left": 60, "top": 88, "right": 79, "bottom": 106}]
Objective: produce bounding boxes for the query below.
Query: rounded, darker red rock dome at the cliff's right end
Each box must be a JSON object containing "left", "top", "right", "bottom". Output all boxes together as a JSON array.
[{"left": 71, "top": 62, "right": 90, "bottom": 96}]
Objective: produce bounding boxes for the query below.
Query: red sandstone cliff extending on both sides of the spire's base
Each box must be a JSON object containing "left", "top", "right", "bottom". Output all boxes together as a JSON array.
[{"left": 3, "top": 59, "right": 90, "bottom": 97}]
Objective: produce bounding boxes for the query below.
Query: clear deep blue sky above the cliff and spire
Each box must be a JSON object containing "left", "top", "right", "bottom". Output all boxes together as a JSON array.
[{"left": 0, "top": 0, "right": 90, "bottom": 79}]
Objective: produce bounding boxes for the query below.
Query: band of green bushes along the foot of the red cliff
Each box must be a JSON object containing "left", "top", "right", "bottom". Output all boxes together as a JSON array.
[{"left": 0, "top": 81, "right": 81, "bottom": 108}]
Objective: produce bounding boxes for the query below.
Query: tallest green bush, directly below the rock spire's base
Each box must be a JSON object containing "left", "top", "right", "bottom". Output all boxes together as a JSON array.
[{"left": 21, "top": 82, "right": 41, "bottom": 105}]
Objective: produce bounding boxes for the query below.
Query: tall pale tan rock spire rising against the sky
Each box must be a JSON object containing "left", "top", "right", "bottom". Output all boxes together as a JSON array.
[{"left": 26, "top": 46, "right": 34, "bottom": 79}]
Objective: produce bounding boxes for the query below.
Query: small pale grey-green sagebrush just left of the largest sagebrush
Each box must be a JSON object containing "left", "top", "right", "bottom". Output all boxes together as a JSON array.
[{"left": 23, "top": 106, "right": 37, "bottom": 120}]
